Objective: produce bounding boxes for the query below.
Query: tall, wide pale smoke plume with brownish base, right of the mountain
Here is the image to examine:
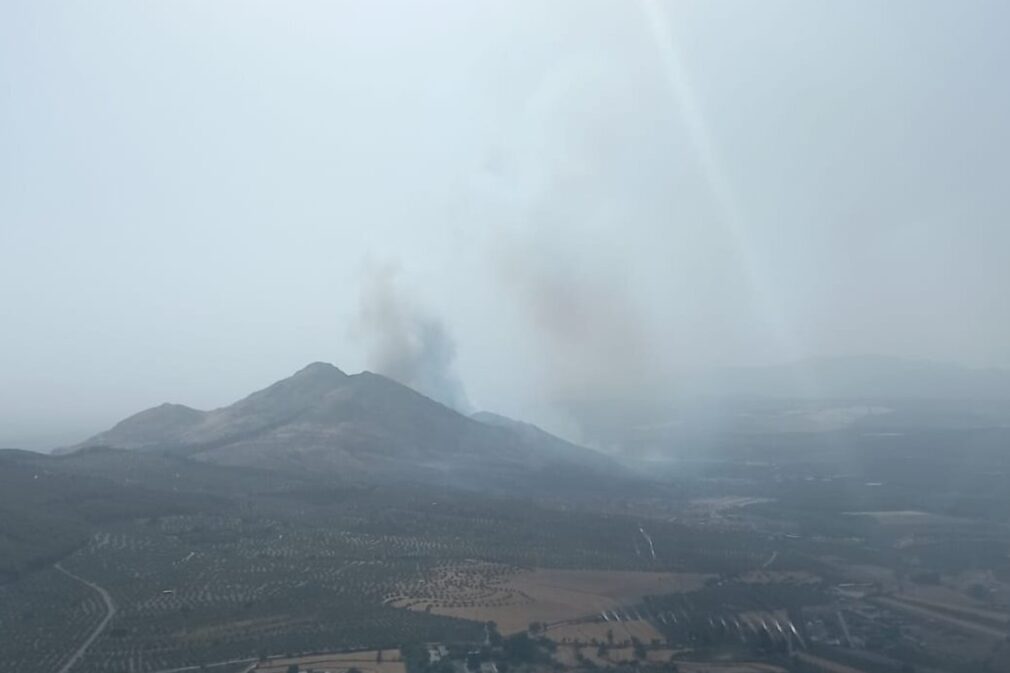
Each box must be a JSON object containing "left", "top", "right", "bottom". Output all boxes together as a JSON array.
[{"left": 479, "top": 57, "right": 671, "bottom": 442}]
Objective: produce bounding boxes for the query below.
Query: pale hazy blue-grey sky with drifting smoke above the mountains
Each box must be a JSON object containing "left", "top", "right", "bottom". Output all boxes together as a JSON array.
[{"left": 0, "top": 0, "right": 1010, "bottom": 448}]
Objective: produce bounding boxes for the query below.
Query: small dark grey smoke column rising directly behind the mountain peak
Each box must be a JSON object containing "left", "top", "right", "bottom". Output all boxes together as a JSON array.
[{"left": 354, "top": 264, "right": 470, "bottom": 412}]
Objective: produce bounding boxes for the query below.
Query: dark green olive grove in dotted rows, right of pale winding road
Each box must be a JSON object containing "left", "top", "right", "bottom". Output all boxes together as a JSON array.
[{"left": 45, "top": 518, "right": 480, "bottom": 671}]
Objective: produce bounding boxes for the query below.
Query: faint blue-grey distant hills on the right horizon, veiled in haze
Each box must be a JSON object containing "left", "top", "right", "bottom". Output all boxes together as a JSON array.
[{"left": 574, "top": 356, "right": 1010, "bottom": 456}]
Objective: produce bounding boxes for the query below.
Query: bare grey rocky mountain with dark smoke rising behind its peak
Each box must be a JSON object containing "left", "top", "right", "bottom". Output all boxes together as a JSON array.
[{"left": 65, "top": 363, "right": 619, "bottom": 490}]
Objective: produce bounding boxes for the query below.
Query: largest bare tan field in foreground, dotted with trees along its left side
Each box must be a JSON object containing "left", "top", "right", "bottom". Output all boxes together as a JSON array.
[{"left": 387, "top": 562, "right": 707, "bottom": 642}]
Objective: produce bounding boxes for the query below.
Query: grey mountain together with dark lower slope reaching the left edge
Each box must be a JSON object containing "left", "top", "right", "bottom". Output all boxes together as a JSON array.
[{"left": 0, "top": 363, "right": 630, "bottom": 583}]
